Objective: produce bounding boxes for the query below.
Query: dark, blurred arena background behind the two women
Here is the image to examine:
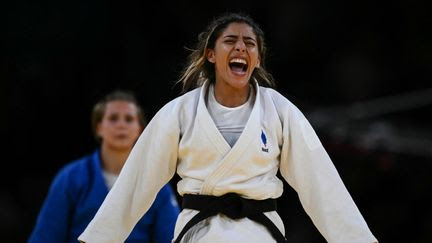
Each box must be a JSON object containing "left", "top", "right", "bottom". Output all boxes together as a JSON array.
[{"left": 0, "top": 0, "right": 432, "bottom": 242}]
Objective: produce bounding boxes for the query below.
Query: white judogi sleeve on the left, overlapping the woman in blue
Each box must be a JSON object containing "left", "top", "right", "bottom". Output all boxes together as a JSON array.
[{"left": 78, "top": 102, "right": 180, "bottom": 243}]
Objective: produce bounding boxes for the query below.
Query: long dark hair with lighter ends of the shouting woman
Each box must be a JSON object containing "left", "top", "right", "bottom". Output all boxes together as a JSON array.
[{"left": 178, "top": 13, "right": 275, "bottom": 92}]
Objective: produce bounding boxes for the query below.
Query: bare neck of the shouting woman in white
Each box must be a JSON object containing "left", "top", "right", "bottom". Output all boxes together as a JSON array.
[{"left": 214, "top": 82, "right": 250, "bottom": 107}]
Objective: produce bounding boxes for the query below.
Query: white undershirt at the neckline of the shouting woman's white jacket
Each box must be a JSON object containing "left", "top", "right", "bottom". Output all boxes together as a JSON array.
[{"left": 207, "top": 85, "right": 254, "bottom": 147}]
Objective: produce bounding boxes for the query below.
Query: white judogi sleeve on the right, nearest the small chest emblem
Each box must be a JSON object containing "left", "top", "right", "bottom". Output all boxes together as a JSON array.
[{"left": 280, "top": 104, "right": 378, "bottom": 243}]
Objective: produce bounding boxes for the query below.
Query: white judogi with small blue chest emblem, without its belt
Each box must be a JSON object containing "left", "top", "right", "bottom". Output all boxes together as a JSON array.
[{"left": 79, "top": 80, "right": 376, "bottom": 243}]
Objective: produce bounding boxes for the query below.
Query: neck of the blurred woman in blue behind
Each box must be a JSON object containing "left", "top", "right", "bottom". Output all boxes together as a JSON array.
[{"left": 101, "top": 145, "right": 130, "bottom": 175}]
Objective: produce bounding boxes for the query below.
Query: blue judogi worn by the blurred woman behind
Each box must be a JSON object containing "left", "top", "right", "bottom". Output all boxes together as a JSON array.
[{"left": 29, "top": 150, "right": 180, "bottom": 243}]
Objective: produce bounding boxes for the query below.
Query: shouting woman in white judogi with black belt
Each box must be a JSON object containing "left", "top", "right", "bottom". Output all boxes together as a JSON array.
[{"left": 79, "top": 11, "right": 377, "bottom": 243}]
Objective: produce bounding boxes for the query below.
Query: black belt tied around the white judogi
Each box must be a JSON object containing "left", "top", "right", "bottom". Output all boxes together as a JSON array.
[{"left": 174, "top": 193, "right": 287, "bottom": 243}]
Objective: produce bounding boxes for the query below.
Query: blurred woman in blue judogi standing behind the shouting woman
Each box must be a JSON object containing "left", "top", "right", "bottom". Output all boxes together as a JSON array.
[{"left": 29, "top": 90, "right": 179, "bottom": 243}]
